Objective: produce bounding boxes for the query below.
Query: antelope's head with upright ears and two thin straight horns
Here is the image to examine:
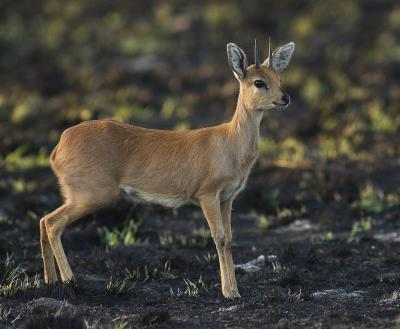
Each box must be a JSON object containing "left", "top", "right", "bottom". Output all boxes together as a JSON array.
[{"left": 227, "top": 40, "right": 294, "bottom": 113}]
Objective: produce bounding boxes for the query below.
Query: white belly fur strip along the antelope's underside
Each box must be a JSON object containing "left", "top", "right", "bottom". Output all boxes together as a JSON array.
[{"left": 120, "top": 185, "right": 192, "bottom": 208}]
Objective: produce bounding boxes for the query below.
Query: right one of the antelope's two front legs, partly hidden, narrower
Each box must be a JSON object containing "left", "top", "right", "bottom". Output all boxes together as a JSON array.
[{"left": 221, "top": 198, "right": 240, "bottom": 297}]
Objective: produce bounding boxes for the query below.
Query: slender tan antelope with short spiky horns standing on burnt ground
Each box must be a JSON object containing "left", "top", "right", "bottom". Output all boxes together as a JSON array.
[{"left": 40, "top": 41, "right": 295, "bottom": 298}]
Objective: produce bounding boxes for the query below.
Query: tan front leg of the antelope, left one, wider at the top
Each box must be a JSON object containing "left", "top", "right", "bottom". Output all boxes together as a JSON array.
[{"left": 199, "top": 194, "right": 235, "bottom": 298}]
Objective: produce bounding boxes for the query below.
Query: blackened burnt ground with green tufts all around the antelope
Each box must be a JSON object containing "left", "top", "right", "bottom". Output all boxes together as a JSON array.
[{"left": 0, "top": 0, "right": 400, "bottom": 329}]
